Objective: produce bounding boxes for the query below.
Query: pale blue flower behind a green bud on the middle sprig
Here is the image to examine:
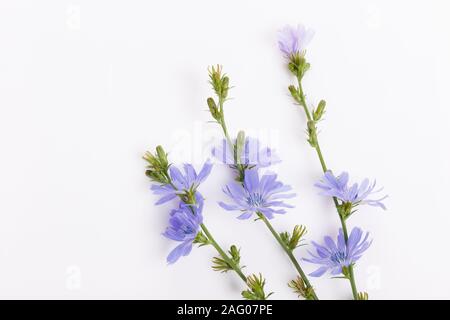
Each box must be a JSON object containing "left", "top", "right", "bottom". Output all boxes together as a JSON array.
[{"left": 212, "top": 137, "right": 281, "bottom": 168}]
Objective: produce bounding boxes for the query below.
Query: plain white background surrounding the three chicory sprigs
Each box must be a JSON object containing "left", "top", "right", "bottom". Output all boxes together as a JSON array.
[{"left": 0, "top": 0, "right": 450, "bottom": 299}]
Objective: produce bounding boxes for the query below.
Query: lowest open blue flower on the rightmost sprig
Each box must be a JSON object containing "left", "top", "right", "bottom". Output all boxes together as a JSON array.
[{"left": 303, "top": 228, "right": 372, "bottom": 277}]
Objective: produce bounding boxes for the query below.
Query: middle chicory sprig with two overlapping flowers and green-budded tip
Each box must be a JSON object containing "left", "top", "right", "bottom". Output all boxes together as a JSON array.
[{"left": 207, "top": 67, "right": 318, "bottom": 300}]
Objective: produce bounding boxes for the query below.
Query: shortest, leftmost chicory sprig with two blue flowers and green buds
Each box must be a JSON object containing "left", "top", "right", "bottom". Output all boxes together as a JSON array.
[{"left": 144, "top": 146, "right": 270, "bottom": 300}]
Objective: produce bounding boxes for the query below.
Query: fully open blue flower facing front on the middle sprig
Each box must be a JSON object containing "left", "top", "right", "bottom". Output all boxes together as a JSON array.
[{"left": 219, "top": 170, "right": 295, "bottom": 219}]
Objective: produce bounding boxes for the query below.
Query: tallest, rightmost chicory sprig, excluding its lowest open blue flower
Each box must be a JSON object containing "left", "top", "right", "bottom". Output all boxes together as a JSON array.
[{"left": 278, "top": 25, "right": 386, "bottom": 300}]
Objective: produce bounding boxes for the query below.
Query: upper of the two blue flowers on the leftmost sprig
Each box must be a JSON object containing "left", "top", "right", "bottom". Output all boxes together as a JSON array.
[{"left": 151, "top": 160, "right": 213, "bottom": 205}]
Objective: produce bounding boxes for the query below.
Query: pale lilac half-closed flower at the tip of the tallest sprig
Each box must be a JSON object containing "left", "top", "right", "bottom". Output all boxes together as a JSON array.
[{"left": 278, "top": 24, "right": 314, "bottom": 58}]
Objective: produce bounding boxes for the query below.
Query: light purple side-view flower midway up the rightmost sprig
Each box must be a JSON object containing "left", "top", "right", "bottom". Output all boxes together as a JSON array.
[{"left": 314, "top": 171, "right": 387, "bottom": 210}]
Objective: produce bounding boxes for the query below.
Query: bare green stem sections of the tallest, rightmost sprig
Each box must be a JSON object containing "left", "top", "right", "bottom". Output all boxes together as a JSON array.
[{"left": 297, "top": 77, "right": 358, "bottom": 300}]
